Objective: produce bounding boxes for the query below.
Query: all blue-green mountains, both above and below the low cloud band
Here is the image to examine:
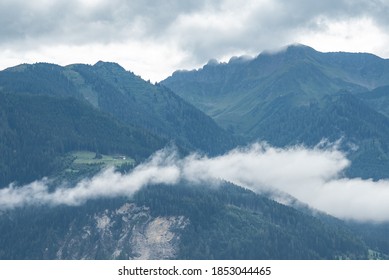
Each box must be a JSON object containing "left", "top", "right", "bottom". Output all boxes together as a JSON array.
[{"left": 0, "top": 45, "right": 389, "bottom": 259}]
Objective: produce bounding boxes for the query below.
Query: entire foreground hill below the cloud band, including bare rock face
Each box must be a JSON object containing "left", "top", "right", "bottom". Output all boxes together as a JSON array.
[{"left": 0, "top": 184, "right": 368, "bottom": 259}]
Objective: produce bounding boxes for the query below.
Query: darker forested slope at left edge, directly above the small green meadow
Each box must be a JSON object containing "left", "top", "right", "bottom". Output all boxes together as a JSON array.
[{"left": 0, "top": 92, "right": 166, "bottom": 187}]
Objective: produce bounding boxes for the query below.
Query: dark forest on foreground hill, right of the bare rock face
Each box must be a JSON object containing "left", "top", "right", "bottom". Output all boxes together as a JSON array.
[{"left": 134, "top": 184, "right": 367, "bottom": 259}]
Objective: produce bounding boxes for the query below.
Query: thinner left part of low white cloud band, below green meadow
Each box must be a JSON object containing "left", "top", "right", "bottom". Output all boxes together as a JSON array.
[{"left": 0, "top": 153, "right": 180, "bottom": 209}]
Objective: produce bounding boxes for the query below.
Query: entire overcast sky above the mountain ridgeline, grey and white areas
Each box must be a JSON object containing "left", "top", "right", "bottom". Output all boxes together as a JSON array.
[{"left": 0, "top": 0, "right": 389, "bottom": 81}]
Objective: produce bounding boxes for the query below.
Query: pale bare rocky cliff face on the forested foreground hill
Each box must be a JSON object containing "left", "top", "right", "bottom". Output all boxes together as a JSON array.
[{"left": 56, "top": 203, "right": 189, "bottom": 259}]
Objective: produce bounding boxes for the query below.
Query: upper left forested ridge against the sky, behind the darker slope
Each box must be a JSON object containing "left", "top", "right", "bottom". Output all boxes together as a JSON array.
[{"left": 0, "top": 62, "right": 236, "bottom": 154}]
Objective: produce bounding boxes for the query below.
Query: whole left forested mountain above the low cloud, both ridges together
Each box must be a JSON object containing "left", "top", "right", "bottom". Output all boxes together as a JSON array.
[{"left": 0, "top": 62, "right": 237, "bottom": 186}]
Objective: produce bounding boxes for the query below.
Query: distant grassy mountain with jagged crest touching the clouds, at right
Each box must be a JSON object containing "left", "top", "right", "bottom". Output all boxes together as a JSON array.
[{"left": 162, "top": 45, "right": 389, "bottom": 137}]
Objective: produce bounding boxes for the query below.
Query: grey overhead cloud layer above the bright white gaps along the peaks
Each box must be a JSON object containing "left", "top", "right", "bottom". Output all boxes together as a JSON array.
[{"left": 0, "top": 0, "right": 389, "bottom": 71}]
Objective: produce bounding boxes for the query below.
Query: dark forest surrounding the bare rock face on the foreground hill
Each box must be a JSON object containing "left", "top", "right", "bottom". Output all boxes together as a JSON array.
[{"left": 0, "top": 183, "right": 368, "bottom": 259}]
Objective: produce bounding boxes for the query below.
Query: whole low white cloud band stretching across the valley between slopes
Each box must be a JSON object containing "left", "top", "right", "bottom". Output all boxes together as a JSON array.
[{"left": 0, "top": 143, "right": 389, "bottom": 222}]
